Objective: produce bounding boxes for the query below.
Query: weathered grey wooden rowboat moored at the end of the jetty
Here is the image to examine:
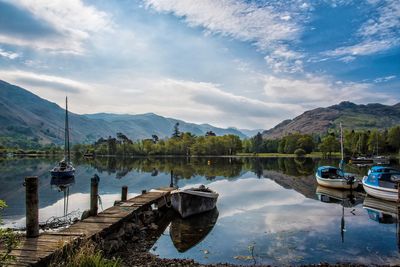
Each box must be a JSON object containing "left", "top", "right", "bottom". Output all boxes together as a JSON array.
[{"left": 171, "top": 185, "right": 219, "bottom": 218}]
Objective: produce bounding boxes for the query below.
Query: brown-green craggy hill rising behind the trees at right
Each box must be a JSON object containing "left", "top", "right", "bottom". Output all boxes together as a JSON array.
[{"left": 263, "top": 101, "right": 400, "bottom": 139}]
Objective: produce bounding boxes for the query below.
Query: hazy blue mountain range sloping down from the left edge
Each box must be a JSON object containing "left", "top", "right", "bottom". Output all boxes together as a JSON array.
[{"left": 0, "top": 80, "right": 246, "bottom": 144}]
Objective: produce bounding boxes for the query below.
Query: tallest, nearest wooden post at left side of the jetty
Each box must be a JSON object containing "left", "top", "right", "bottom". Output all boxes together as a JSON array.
[{"left": 25, "top": 176, "right": 39, "bottom": 238}]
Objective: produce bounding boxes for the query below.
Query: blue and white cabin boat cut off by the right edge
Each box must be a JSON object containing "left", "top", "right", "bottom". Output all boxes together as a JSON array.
[{"left": 362, "top": 166, "right": 400, "bottom": 201}]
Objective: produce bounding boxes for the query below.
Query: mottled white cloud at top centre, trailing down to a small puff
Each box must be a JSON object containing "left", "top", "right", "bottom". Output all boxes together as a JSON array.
[{"left": 145, "top": 0, "right": 310, "bottom": 73}]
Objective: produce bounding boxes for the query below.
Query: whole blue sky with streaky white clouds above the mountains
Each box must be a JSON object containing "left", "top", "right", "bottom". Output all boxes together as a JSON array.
[{"left": 0, "top": 0, "right": 400, "bottom": 129}]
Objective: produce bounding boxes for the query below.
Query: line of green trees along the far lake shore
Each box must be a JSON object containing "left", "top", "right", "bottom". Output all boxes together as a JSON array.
[{"left": 0, "top": 123, "right": 400, "bottom": 156}]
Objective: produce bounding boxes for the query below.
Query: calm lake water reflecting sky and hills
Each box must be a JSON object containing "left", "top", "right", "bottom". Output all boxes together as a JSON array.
[{"left": 0, "top": 158, "right": 400, "bottom": 265}]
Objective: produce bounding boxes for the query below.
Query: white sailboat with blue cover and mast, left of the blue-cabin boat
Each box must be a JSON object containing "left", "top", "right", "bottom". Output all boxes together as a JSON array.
[{"left": 315, "top": 123, "right": 359, "bottom": 189}]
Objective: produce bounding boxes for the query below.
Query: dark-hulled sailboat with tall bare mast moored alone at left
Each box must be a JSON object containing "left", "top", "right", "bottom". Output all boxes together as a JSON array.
[{"left": 50, "top": 97, "right": 75, "bottom": 179}]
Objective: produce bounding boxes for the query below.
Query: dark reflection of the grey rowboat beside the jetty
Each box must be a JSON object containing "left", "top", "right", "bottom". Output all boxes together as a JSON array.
[{"left": 169, "top": 208, "right": 219, "bottom": 253}]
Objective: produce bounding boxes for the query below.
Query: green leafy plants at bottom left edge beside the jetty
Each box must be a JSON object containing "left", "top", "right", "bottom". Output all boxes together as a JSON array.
[{"left": 0, "top": 200, "right": 18, "bottom": 266}]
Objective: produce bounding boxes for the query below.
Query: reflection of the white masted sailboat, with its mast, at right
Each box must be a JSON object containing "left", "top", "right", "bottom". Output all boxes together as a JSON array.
[{"left": 316, "top": 186, "right": 362, "bottom": 242}]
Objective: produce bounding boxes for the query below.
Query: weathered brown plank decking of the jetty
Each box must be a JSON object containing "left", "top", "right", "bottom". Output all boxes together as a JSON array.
[{"left": 3, "top": 187, "right": 174, "bottom": 266}]
